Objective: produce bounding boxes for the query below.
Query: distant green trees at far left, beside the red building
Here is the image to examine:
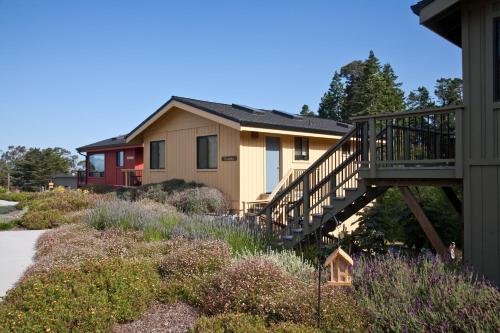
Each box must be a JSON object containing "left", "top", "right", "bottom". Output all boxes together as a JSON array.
[{"left": 0, "top": 146, "right": 77, "bottom": 191}]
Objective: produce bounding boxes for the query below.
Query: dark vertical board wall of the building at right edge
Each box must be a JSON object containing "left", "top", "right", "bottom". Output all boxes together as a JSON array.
[{"left": 462, "top": 0, "right": 500, "bottom": 285}]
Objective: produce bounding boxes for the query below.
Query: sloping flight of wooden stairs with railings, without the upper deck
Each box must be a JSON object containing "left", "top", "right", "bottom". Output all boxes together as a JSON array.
[{"left": 249, "top": 127, "right": 386, "bottom": 247}]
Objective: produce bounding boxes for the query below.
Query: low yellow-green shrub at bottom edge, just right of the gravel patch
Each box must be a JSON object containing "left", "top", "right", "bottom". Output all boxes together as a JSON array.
[{"left": 192, "top": 313, "right": 269, "bottom": 333}]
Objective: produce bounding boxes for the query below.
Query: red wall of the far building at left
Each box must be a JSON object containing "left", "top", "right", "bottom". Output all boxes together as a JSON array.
[{"left": 87, "top": 148, "right": 144, "bottom": 186}]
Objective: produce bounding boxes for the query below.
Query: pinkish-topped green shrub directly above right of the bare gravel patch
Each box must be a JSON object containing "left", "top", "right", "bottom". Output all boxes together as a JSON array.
[{"left": 159, "top": 240, "right": 231, "bottom": 304}]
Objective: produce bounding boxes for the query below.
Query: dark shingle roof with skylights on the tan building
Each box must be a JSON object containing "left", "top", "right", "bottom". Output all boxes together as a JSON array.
[{"left": 128, "top": 96, "right": 352, "bottom": 135}]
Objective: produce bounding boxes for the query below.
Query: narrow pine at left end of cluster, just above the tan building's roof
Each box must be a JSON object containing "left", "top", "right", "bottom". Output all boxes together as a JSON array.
[{"left": 318, "top": 72, "right": 347, "bottom": 121}]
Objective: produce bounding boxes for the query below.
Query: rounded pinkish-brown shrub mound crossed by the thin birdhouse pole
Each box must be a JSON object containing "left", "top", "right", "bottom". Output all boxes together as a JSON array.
[{"left": 201, "top": 257, "right": 367, "bottom": 332}]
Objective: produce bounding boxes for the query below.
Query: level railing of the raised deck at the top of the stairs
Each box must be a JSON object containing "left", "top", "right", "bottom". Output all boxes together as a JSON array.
[{"left": 352, "top": 106, "right": 463, "bottom": 178}]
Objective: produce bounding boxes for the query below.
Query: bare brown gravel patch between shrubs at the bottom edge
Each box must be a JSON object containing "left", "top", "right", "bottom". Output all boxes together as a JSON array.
[{"left": 113, "top": 302, "right": 198, "bottom": 333}]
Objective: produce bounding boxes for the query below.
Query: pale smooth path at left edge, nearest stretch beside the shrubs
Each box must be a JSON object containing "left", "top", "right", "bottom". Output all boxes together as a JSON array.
[{"left": 0, "top": 230, "right": 44, "bottom": 298}]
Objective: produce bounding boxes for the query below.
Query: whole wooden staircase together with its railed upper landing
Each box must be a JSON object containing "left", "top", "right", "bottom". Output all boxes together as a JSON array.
[{"left": 248, "top": 107, "right": 461, "bottom": 247}]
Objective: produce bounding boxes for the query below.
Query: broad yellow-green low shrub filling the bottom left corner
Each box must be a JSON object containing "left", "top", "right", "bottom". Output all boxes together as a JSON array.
[{"left": 0, "top": 259, "right": 158, "bottom": 332}]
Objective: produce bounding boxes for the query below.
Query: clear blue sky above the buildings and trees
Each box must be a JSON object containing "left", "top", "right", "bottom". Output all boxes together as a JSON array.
[{"left": 0, "top": 0, "right": 461, "bottom": 150}]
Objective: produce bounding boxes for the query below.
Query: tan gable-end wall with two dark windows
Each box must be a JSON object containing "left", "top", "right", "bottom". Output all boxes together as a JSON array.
[{"left": 143, "top": 108, "right": 240, "bottom": 209}]
